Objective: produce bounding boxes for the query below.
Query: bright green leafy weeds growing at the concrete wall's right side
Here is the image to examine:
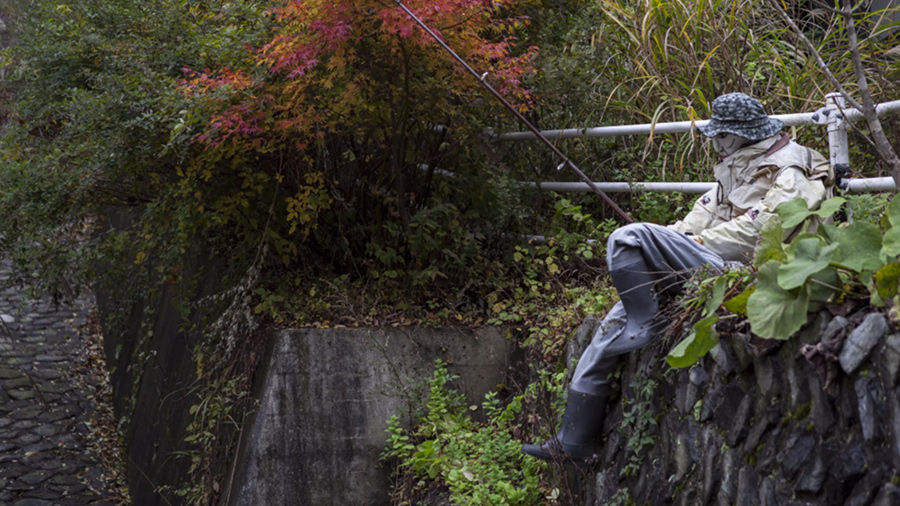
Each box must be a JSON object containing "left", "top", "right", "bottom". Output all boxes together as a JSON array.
[{"left": 383, "top": 360, "right": 564, "bottom": 505}]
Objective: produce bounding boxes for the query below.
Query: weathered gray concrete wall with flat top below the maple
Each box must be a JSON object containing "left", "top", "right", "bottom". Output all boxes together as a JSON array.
[{"left": 227, "top": 327, "right": 509, "bottom": 505}]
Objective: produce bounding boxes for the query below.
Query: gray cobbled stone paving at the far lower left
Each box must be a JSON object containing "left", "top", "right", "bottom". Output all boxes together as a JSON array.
[{"left": 0, "top": 261, "right": 121, "bottom": 506}]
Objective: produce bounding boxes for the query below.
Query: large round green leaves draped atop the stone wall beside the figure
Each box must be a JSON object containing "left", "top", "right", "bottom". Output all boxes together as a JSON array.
[{"left": 666, "top": 197, "right": 900, "bottom": 367}]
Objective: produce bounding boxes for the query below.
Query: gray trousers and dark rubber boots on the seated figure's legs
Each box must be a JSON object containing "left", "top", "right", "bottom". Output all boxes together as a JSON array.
[{"left": 522, "top": 223, "right": 725, "bottom": 460}]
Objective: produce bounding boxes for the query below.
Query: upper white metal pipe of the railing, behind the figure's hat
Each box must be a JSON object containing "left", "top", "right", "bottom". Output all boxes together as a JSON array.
[{"left": 497, "top": 100, "right": 900, "bottom": 141}]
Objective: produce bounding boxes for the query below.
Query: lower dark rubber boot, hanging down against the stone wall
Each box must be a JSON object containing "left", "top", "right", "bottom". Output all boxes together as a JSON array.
[{"left": 522, "top": 389, "right": 607, "bottom": 461}]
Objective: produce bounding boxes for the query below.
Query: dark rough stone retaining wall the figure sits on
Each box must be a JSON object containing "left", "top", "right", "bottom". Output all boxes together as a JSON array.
[{"left": 570, "top": 310, "right": 900, "bottom": 505}]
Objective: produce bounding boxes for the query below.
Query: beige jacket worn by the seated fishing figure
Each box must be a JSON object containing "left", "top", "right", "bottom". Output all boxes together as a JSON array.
[{"left": 670, "top": 133, "right": 834, "bottom": 262}]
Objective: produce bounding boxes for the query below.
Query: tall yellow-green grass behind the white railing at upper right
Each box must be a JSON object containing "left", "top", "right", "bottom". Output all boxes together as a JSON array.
[{"left": 593, "top": 0, "right": 900, "bottom": 179}]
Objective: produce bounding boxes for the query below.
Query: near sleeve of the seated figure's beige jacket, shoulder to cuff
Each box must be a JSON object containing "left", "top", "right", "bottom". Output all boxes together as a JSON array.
[{"left": 698, "top": 167, "right": 825, "bottom": 261}]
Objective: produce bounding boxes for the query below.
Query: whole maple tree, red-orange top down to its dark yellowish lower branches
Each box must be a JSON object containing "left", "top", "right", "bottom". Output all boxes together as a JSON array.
[{"left": 180, "top": 0, "right": 536, "bottom": 260}]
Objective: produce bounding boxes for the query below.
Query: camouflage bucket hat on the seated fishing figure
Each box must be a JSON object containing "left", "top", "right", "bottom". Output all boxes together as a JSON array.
[{"left": 697, "top": 93, "right": 784, "bottom": 141}]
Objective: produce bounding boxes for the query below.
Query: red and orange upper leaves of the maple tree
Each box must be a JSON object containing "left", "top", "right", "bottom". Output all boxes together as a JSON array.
[{"left": 181, "top": 0, "right": 536, "bottom": 151}]
